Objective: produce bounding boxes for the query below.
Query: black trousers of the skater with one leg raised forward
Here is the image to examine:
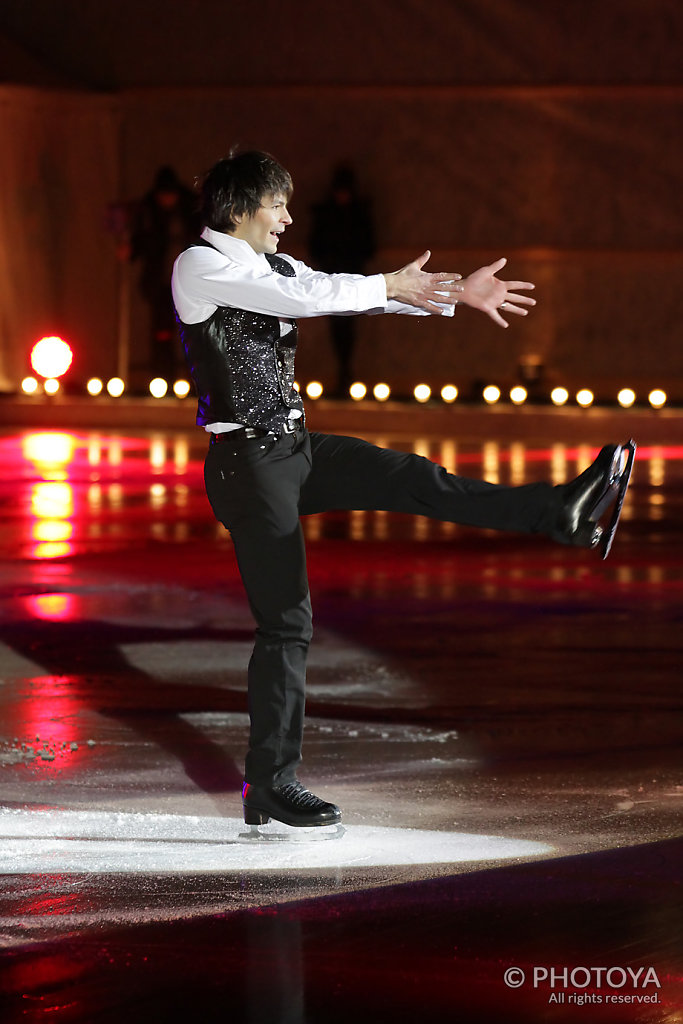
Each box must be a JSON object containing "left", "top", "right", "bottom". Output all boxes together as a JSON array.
[{"left": 205, "top": 430, "right": 560, "bottom": 785}]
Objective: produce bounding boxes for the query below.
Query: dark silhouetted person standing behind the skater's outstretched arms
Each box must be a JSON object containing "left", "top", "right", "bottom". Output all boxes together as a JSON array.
[{"left": 309, "top": 164, "right": 375, "bottom": 397}]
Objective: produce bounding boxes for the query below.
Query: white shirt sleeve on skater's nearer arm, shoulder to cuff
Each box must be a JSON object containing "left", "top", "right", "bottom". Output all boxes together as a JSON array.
[{"left": 172, "top": 246, "right": 387, "bottom": 324}]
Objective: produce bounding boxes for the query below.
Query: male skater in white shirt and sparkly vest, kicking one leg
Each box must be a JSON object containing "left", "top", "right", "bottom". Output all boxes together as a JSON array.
[{"left": 172, "top": 153, "right": 623, "bottom": 825}]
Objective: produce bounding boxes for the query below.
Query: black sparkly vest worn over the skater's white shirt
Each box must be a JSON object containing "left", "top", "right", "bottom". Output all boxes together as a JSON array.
[{"left": 178, "top": 239, "right": 303, "bottom": 433}]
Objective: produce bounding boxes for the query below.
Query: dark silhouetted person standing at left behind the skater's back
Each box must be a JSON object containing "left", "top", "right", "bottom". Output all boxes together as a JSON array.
[{"left": 130, "top": 167, "right": 200, "bottom": 381}]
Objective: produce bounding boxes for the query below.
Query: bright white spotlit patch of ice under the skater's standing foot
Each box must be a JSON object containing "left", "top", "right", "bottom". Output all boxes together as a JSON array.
[{"left": 0, "top": 808, "right": 553, "bottom": 874}]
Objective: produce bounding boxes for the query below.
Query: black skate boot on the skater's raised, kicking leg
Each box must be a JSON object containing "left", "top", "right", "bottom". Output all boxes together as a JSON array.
[{"left": 550, "top": 440, "right": 636, "bottom": 558}]
